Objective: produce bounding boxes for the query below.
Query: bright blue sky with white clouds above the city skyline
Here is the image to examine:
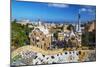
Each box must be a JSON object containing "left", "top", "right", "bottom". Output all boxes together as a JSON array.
[{"left": 11, "top": 0, "right": 96, "bottom": 22}]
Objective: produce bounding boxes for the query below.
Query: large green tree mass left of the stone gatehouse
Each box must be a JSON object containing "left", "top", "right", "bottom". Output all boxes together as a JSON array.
[{"left": 11, "top": 20, "right": 31, "bottom": 48}]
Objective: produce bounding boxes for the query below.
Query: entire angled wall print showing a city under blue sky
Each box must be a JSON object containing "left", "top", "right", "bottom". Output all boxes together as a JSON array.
[{"left": 11, "top": 0, "right": 96, "bottom": 66}]
